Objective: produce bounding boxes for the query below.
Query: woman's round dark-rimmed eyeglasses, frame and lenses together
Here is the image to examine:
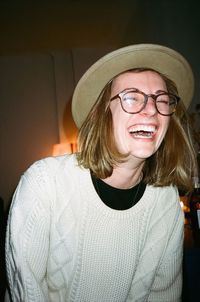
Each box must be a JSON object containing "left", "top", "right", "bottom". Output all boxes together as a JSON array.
[{"left": 110, "top": 88, "right": 180, "bottom": 116}]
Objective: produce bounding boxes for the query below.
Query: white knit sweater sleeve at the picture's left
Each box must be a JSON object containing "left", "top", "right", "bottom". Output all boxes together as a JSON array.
[{"left": 6, "top": 164, "right": 53, "bottom": 302}]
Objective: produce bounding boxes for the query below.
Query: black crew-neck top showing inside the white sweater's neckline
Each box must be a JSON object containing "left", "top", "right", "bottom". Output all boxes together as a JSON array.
[{"left": 91, "top": 174, "right": 146, "bottom": 210}]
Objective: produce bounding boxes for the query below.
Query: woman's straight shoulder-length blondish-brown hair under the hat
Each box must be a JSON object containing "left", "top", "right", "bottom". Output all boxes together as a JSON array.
[{"left": 77, "top": 68, "right": 196, "bottom": 191}]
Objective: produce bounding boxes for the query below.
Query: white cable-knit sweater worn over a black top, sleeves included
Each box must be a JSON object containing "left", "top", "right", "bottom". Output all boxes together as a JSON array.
[{"left": 6, "top": 155, "right": 183, "bottom": 302}]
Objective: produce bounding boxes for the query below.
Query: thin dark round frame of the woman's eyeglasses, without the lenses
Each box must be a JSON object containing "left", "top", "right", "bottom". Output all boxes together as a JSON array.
[{"left": 110, "top": 88, "right": 180, "bottom": 116}]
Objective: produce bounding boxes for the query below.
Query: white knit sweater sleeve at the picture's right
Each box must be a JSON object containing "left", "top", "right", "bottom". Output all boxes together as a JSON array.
[{"left": 148, "top": 188, "right": 184, "bottom": 302}]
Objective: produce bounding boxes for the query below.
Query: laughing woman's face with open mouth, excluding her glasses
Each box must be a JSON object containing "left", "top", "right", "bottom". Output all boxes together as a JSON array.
[{"left": 110, "top": 71, "right": 170, "bottom": 160}]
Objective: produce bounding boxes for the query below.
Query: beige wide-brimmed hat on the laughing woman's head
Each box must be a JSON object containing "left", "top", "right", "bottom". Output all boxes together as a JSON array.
[{"left": 72, "top": 44, "right": 194, "bottom": 128}]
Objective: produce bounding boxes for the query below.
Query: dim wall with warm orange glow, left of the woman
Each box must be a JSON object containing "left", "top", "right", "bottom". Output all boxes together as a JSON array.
[{"left": 0, "top": 48, "right": 111, "bottom": 207}]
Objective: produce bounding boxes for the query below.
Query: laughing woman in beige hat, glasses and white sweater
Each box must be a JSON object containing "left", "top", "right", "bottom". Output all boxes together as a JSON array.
[{"left": 6, "top": 44, "right": 195, "bottom": 302}]
